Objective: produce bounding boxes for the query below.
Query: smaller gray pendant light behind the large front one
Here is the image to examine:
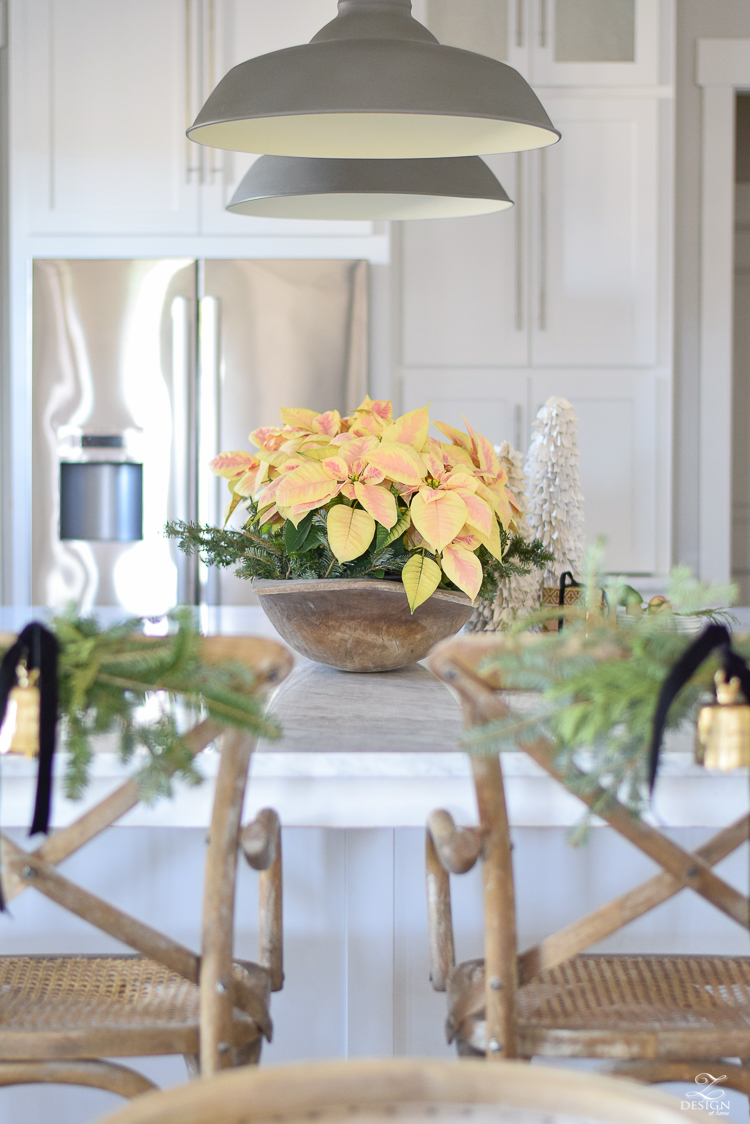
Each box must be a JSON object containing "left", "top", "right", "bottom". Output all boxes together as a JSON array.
[{"left": 227, "top": 156, "right": 513, "bottom": 219}]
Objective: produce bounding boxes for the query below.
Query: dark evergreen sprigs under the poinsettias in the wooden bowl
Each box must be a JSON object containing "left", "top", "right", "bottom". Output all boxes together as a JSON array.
[{"left": 165, "top": 499, "right": 552, "bottom": 600}]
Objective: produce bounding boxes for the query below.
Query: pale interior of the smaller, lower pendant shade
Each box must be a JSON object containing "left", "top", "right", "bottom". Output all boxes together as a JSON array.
[{"left": 227, "top": 191, "right": 513, "bottom": 221}]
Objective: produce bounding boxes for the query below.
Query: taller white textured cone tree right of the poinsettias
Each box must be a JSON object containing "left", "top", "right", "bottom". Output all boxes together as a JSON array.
[{"left": 526, "top": 398, "right": 584, "bottom": 584}]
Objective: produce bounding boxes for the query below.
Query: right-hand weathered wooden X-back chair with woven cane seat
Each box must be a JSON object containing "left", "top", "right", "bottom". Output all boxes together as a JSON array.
[{"left": 426, "top": 636, "right": 750, "bottom": 1094}]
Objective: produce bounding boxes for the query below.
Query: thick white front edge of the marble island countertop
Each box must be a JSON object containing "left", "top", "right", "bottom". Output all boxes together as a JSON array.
[{"left": 0, "top": 750, "right": 748, "bottom": 828}]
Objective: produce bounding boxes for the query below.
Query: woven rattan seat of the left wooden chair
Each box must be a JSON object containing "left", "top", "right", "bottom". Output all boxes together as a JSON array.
[{"left": 0, "top": 955, "right": 270, "bottom": 1059}]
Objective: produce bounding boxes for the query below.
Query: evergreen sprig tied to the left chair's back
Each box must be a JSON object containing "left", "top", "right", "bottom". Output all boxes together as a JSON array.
[{"left": 0, "top": 611, "right": 280, "bottom": 801}]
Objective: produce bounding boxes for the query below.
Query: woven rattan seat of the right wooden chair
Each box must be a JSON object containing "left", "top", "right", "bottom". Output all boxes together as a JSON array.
[{"left": 448, "top": 954, "right": 750, "bottom": 1058}]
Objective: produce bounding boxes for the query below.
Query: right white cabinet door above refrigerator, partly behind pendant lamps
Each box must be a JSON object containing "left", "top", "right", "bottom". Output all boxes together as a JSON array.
[{"left": 199, "top": 0, "right": 372, "bottom": 235}]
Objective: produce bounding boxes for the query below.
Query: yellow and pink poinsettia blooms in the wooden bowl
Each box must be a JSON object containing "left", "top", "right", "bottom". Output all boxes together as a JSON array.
[{"left": 210, "top": 397, "right": 518, "bottom": 611}]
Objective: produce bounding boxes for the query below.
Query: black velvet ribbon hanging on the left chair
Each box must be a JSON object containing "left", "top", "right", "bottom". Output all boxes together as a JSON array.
[{"left": 0, "top": 620, "right": 57, "bottom": 894}]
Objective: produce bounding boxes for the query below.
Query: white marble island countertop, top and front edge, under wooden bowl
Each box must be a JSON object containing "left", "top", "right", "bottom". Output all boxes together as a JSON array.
[{"left": 0, "top": 607, "right": 748, "bottom": 827}]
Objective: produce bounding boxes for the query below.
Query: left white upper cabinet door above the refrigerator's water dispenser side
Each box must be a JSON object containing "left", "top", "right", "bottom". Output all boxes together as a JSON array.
[{"left": 19, "top": 0, "right": 199, "bottom": 234}]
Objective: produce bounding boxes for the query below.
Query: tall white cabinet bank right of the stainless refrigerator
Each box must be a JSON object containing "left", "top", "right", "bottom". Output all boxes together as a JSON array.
[{"left": 395, "top": 0, "right": 674, "bottom": 575}]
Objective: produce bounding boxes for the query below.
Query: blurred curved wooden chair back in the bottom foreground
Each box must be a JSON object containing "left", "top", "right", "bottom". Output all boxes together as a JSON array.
[{"left": 91, "top": 1058, "right": 685, "bottom": 1124}]
